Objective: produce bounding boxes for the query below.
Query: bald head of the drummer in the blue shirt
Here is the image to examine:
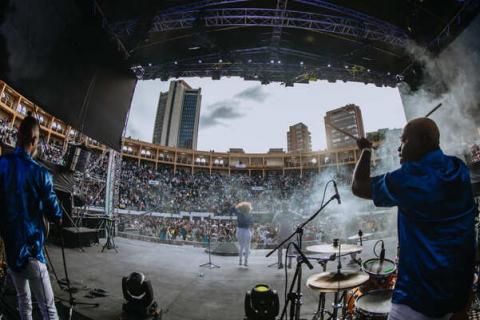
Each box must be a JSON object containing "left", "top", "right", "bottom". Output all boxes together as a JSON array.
[{"left": 398, "top": 118, "right": 440, "bottom": 163}]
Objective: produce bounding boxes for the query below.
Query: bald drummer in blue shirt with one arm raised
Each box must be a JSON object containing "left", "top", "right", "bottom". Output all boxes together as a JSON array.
[{"left": 352, "top": 118, "right": 476, "bottom": 320}]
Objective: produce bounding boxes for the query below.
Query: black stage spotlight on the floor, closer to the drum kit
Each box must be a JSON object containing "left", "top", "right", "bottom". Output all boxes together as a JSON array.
[{"left": 245, "top": 284, "right": 280, "bottom": 320}]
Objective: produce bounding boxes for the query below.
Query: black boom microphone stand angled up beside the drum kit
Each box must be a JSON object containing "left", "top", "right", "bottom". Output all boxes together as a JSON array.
[{"left": 266, "top": 193, "right": 340, "bottom": 320}]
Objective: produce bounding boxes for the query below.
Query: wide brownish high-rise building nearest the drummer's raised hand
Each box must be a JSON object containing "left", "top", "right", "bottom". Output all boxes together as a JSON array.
[{"left": 324, "top": 104, "right": 365, "bottom": 149}]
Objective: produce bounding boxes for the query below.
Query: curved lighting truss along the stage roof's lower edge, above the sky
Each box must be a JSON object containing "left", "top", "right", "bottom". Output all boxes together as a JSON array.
[{"left": 138, "top": 47, "right": 398, "bottom": 87}]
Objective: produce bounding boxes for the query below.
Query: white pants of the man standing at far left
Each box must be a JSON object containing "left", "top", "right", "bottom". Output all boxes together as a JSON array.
[{"left": 8, "top": 259, "right": 58, "bottom": 320}]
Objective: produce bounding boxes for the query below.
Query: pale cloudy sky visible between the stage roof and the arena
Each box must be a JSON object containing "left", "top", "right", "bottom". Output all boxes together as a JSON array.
[{"left": 126, "top": 77, "right": 406, "bottom": 153}]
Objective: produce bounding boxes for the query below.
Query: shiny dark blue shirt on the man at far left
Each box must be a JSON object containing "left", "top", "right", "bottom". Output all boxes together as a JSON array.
[{"left": 0, "top": 148, "right": 62, "bottom": 272}]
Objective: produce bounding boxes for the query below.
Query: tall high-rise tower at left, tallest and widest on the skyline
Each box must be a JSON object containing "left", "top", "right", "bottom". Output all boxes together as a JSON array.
[{"left": 153, "top": 80, "right": 202, "bottom": 149}]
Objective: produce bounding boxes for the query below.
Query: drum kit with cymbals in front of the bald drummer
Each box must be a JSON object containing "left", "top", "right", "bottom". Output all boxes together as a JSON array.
[{"left": 306, "top": 233, "right": 397, "bottom": 320}]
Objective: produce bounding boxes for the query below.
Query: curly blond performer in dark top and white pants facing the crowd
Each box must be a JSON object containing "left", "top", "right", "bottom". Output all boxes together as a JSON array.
[{"left": 235, "top": 202, "right": 253, "bottom": 266}]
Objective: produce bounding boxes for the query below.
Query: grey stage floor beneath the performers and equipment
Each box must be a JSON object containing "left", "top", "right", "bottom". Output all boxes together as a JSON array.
[{"left": 44, "top": 238, "right": 396, "bottom": 320}]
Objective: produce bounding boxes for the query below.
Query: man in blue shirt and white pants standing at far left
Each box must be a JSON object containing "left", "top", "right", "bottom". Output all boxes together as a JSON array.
[{"left": 0, "top": 115, "right": 62, "bottom": 320}]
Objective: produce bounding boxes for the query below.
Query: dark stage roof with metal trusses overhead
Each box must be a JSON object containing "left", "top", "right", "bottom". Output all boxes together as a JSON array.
[{"left": 99, "top": 0, "right": 480, "bottom": 86}]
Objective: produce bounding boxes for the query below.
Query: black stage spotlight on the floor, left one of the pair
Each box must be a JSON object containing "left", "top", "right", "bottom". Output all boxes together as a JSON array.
[{"left": 122, "top": 272, "right": 157, "bottom": 317}]
